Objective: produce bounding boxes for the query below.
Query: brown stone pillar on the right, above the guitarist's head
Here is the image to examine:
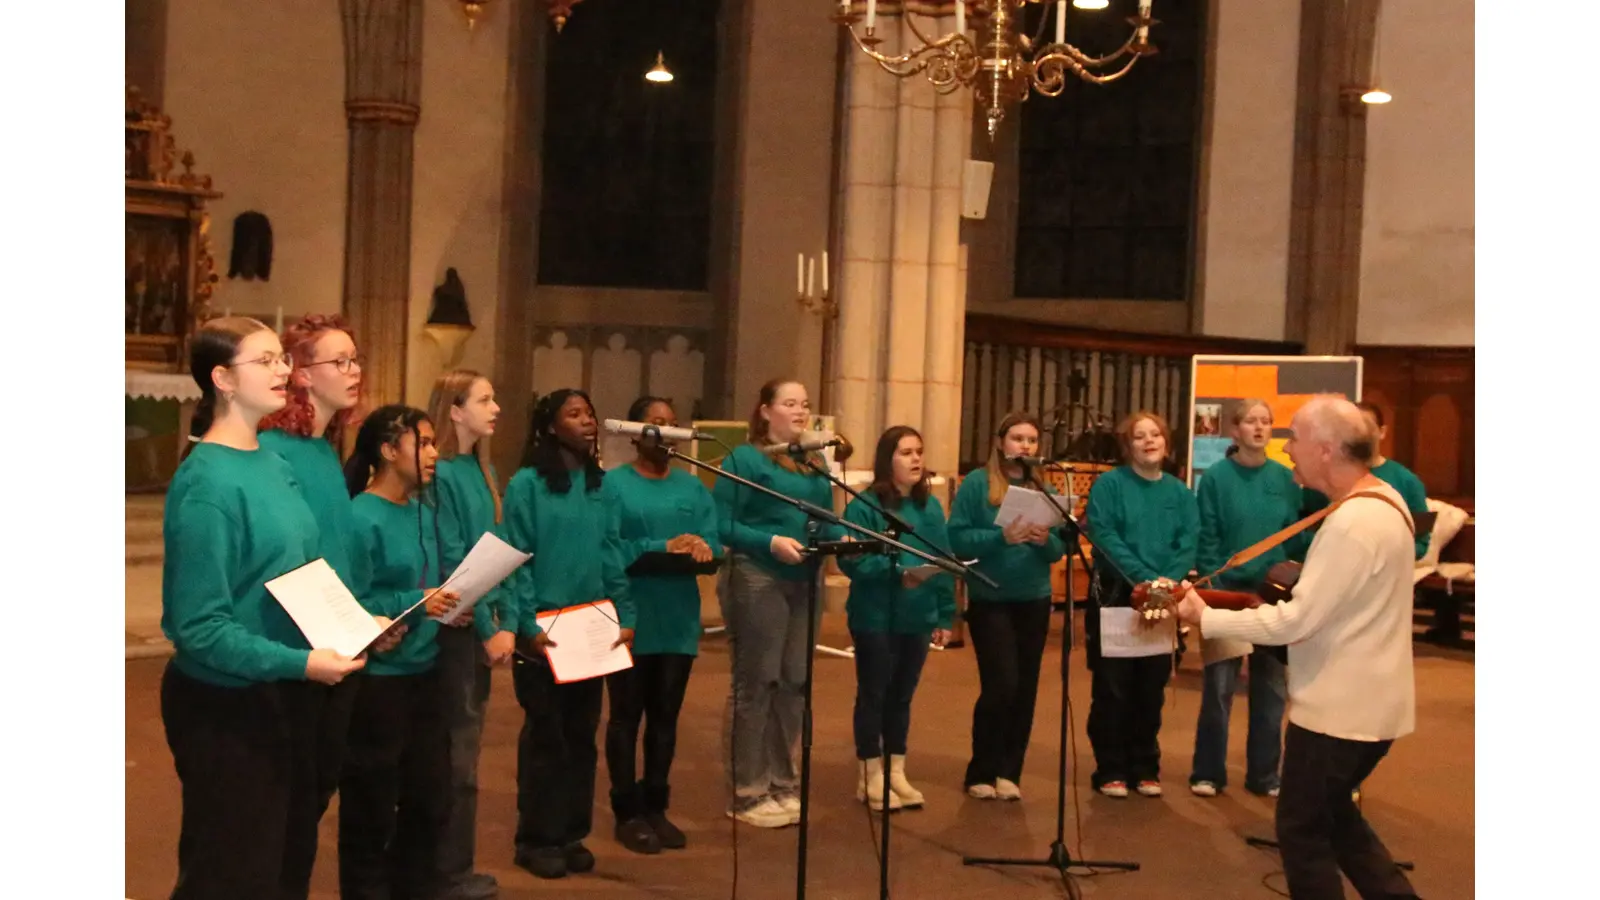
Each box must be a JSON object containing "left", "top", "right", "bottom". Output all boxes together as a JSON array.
[{"left": 1285, "top": 0, "right": 1379, "bottom": 356}]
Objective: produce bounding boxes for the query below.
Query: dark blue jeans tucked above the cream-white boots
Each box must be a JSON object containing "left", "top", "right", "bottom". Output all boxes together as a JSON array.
[{"left": 850, "top": 631, "right": 930, "bottom": 759}]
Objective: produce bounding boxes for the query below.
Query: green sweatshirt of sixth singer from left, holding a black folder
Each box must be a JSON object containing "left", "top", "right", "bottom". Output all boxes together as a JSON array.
[{"left": 600, "top": 466, "right": 722, "bottom": 657}]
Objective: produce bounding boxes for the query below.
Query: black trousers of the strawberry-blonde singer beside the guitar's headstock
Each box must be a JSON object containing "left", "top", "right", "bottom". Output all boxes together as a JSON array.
[{"left": 1083, "top": 605, "right": 1173, "bottom": 788}]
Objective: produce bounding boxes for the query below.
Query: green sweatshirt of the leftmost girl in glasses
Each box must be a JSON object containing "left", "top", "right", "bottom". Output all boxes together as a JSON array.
[{"left": 162, "top": 444, "right": 320, "bottom": 687}]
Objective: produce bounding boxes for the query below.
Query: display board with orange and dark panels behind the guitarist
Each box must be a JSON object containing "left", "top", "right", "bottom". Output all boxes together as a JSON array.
[{"left": 1189, "top": 356, "right": 1362, "bottom": 487}]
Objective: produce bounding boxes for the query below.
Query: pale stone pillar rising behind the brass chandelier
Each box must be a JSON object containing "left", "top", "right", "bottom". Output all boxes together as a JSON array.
[{"left": 830, "top": 10, "right": 973, "bottom": 474}]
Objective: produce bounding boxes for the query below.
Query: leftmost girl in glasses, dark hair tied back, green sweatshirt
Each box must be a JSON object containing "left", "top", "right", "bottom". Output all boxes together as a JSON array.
[{"left": 162, "top": 317, "right": 365, "bottom": 900}]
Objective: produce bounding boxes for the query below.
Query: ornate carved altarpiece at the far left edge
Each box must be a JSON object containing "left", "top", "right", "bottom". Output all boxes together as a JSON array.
[{"left": 123, "top": 85, "right": 221, "bottom": 372}]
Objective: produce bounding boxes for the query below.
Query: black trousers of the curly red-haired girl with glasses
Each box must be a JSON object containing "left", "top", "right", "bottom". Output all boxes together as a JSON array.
[{"left": 278, "top": 677, "right": 360, "bottom": 900}]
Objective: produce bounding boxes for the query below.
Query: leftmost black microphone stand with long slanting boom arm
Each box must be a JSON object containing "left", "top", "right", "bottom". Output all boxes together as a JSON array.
[{"left": 643, "top": 429, "right": 966, "bottom": 900}]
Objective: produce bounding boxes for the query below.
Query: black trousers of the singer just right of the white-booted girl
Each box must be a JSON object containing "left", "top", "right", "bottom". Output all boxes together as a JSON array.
[{"left": 965, "top": 597, "right": 1050, "bottom": 786}]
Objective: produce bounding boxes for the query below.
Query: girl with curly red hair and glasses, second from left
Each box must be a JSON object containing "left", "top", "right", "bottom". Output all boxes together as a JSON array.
[{"left": 261, "top": 315, "right": 371, "bottom": 897}]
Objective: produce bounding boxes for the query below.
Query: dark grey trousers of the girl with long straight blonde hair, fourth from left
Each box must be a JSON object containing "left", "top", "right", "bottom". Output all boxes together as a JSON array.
[{"left": 437, "top": 628, "right": 490, "bottom": 884}]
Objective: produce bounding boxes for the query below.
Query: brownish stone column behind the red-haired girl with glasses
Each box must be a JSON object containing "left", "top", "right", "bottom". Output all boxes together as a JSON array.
[{"left": 339, "top": 0, "right": 422, "bottom": 404}]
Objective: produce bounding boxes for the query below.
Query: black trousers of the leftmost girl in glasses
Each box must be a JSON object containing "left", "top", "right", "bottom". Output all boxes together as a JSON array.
[{"left": 162, "top": 663, "right": 306, "bottom": 900}]
